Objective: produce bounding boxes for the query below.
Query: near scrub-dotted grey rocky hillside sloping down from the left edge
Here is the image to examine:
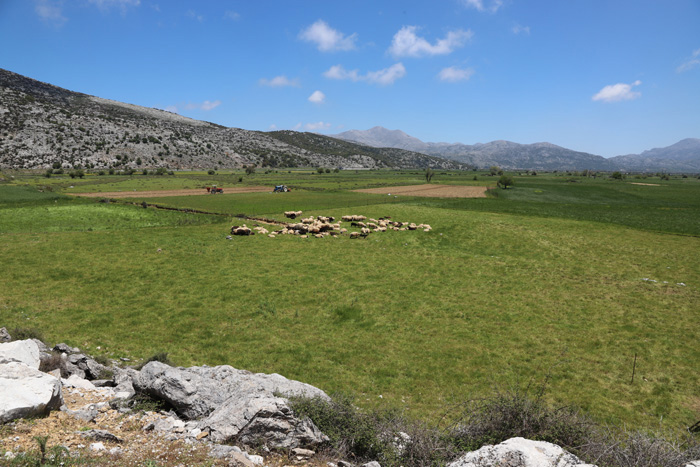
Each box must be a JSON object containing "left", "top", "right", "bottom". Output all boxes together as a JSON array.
[{"left": 0, "top": 69, "right": 461, "bottom": 169}]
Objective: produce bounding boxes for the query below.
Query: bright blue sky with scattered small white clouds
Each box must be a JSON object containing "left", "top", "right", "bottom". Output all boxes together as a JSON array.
[{"left": 0, "top": 0, "right": 700, "bottom": 157}]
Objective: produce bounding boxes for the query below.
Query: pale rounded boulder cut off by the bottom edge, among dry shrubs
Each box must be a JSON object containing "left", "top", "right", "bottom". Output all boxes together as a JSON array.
[{"left": 448, "top": 438, "right": 595, "bottom": 467}]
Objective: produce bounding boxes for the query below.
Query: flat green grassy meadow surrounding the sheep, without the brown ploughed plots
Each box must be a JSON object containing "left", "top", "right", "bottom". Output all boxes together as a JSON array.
[{"left": 0, "top": 170, "right": 700, "bottom": 431}]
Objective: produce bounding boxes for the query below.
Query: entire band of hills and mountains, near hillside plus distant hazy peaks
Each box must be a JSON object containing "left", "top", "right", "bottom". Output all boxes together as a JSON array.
[{"left": 0, "top": 69, "right": 700, "bottom": 172}]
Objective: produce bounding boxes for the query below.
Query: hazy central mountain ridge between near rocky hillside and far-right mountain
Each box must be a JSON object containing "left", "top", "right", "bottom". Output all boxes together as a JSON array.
[{"left": 335, "top": 127, "right": 617, "bottom": 170}]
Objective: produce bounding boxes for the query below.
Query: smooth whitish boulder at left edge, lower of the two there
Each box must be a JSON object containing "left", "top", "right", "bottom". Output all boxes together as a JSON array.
[{"left": 0, "top": 362, "right": 63, "bottom": 423}]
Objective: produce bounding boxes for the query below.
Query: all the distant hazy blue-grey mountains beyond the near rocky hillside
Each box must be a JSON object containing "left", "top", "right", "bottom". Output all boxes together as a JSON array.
[{"left": 334, "top": 126, "right": 700, "bottom": 172}]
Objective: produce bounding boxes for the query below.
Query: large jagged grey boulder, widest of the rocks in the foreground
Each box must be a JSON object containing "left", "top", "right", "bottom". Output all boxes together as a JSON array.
[{"left": 133, "top": 362, "right": 328, "bottom": 449}]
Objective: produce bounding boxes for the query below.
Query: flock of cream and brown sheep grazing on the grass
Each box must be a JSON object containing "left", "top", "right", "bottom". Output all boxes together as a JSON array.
[{"left": 229, "top": 211, "right": 432, "bottom": 238}]
